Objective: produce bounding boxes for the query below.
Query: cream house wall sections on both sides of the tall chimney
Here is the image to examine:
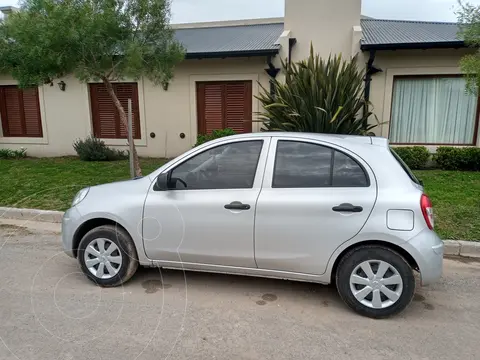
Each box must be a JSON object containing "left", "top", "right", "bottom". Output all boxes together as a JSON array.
[{"left": 0, "top": 45, "right": 480, "bottom": 157}]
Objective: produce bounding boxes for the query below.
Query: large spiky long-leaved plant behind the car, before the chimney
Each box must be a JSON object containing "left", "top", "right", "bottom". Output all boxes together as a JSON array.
[{"left": 257, "top": 47, "right": 378, "bottom": 135}]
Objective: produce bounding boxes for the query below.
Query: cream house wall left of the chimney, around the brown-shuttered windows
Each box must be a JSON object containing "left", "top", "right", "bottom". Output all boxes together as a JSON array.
[{"left": 0, "top": 57, "right": 269, "bottom": 157}]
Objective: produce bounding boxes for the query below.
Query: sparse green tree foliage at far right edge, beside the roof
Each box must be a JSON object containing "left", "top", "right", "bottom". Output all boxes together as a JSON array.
[{"left": 456, "top": 0, "right": 480, "bottom": 94}]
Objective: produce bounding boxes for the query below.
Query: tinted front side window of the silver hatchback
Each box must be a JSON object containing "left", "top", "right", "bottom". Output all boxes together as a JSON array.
[{"left": 171, "top": 140, "right": 263, "bottom": 190}]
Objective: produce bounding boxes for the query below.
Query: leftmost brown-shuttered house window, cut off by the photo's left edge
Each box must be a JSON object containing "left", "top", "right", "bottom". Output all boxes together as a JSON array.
[{"left": 0, "top": 85, "right": 43, "bottom": 138}]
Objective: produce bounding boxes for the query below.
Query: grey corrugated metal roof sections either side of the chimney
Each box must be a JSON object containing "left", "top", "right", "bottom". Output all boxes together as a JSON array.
[{"left": 175, "top": 16, "right": 465, "bottom": 59}]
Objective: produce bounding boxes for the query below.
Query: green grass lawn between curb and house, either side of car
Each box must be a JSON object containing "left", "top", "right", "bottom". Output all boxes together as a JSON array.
[{"left": 0, "top": 158, "right": 480, "bottom": 240}]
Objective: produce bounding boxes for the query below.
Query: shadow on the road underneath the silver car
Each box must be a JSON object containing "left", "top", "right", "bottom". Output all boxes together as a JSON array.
[{"left": 53, "top": 258, "right": 434, "bottom": 320}]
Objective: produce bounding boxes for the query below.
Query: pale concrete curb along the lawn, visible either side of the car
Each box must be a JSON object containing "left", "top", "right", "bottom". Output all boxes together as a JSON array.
[{"left": 0, "top": 207, "right": 480, "bottom": 258}]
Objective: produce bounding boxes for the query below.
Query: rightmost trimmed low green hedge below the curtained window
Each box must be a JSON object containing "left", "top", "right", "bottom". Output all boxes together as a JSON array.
[{"left": 433, "top": 146, "right": 480, "bottom": 171}]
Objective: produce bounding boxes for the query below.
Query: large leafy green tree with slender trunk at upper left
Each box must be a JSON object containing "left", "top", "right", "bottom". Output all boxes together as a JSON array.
[{"left": 0, "top": 0, "right": 184, "bottom": 176}]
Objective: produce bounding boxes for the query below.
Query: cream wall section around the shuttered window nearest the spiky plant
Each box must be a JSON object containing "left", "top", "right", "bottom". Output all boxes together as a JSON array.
[{"left": 140, "top": 57, "right": 269, "bottom": 157}]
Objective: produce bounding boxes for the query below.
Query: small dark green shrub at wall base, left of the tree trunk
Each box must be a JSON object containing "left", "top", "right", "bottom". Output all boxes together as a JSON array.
[{"left": 73, "top": 135, "right": 128, "bottom": 161}]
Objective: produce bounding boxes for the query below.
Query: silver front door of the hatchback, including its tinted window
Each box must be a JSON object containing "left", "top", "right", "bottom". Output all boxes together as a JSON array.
[{"left": 143, "top": 136, "right": 270, "bottom": 268}]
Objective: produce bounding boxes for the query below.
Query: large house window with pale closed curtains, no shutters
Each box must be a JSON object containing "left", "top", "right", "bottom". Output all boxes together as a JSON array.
[{"left": 390, "top": 76, "right": 478, "bottom": 145}]
